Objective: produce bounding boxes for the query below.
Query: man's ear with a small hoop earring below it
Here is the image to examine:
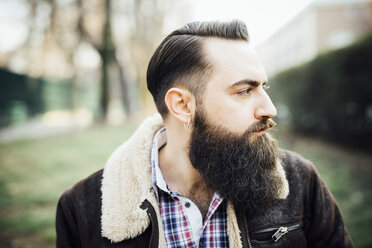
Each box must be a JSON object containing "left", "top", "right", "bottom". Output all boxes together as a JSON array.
[{"left": 164, "top": 88, "right": 195, "bottom": 123}]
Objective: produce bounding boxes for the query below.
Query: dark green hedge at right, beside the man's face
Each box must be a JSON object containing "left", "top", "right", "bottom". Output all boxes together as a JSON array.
[{"left": 271, "top": 34, "right": 372, "bottom": 149}]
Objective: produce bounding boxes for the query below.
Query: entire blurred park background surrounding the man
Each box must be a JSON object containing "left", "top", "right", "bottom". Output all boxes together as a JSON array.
[{"left": 0, "top": 0, "right": 372, "bottom": 248}]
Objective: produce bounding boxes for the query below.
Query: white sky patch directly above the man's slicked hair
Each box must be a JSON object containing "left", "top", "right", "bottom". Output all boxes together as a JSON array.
[{"left": 191, "top": 0, "right": 312, "bottom": 45}]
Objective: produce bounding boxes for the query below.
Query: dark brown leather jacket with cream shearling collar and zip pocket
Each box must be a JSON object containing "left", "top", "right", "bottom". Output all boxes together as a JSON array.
[{"left": 56, "top": 115, "right": 353, "bottom": 248}]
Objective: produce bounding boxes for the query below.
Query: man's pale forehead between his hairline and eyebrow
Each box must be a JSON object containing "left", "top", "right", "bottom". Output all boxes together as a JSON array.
[{"left": 204, "top": 38, "right": 267, "bottom": 87}]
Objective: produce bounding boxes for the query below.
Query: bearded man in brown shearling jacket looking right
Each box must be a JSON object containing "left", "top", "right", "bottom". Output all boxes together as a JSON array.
[{"left": 56, "top": 21, "right": 352, "bottom": 248}]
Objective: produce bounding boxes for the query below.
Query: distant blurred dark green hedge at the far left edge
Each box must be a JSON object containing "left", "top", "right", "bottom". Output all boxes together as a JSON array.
[{"left": 0, "top": 68, "right": 72, "bottom": 127}]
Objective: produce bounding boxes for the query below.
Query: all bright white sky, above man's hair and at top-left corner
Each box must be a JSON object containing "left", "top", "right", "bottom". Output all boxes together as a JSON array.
[{"left": 0, "top": 0, "right": 312, "bottom": 51}]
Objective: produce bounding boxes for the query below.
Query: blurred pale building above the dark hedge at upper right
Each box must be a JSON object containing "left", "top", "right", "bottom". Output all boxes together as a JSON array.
[{"left": 257, "top": 0, "right": 372, "bottom": 75}]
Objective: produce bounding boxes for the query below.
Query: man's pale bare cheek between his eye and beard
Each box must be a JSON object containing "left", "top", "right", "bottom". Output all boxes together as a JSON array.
[{"left": 204, "top": 93, "right": 256, "bottom": 132}]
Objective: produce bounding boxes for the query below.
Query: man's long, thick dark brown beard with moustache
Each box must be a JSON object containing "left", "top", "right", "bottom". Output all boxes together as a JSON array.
[{"left": 188, "top": 110, "right": 282, "bottom": 214}]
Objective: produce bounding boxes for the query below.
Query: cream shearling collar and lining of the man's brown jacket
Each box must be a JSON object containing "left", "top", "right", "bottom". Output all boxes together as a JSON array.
[{"left": 101, "top": 114, "right": 289, "bottom": 244}]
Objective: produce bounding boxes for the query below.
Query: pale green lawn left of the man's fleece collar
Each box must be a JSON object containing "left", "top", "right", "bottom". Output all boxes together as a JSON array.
[{"left": 0, "top": 125, "right": 135, "bottom": 248}]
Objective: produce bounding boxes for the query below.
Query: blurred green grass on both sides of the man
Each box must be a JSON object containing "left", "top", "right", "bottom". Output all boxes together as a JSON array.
[{"left": 0, "top": 125, "right": 372, "bottom": 248}]
